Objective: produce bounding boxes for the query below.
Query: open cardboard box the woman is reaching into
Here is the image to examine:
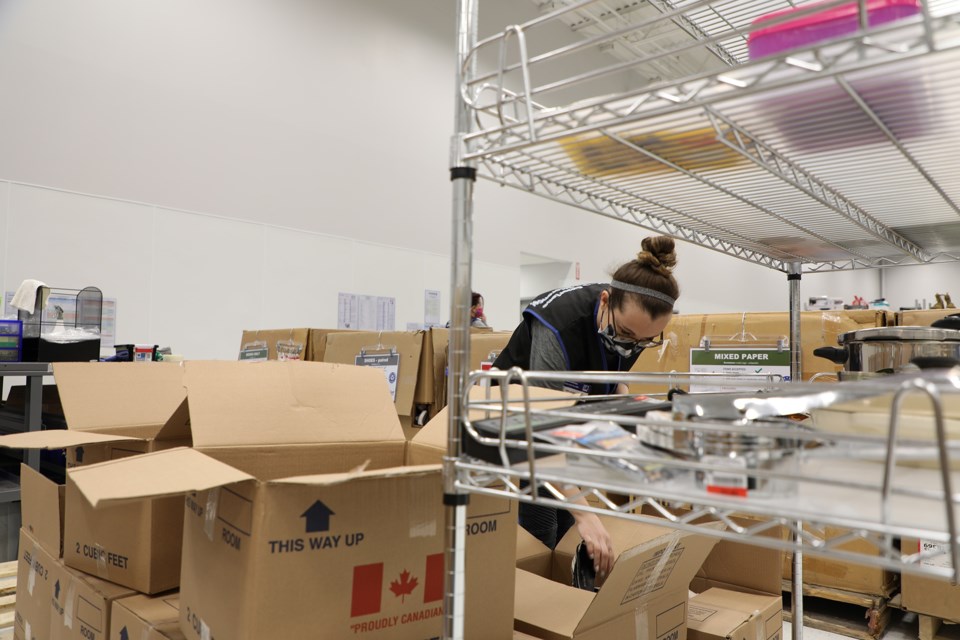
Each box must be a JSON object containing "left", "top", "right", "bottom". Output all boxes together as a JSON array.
[{"left": 514, "top": 521, "right": 716, "bottom": 640}]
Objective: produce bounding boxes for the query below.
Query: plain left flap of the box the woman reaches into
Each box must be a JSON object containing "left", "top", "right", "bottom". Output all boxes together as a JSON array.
[{"left": 514, "top": 569, "right": 594, "bottom": 638}]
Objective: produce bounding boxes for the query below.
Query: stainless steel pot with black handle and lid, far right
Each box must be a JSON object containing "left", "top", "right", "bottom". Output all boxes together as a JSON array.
[{"left": 813, "top": 327, "right": 960, "bottom": 373}]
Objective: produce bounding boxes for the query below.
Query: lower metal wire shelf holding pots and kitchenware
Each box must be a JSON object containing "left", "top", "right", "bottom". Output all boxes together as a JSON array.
[{"left": 456, "top": 369, "right": 960, "bottom": 580}]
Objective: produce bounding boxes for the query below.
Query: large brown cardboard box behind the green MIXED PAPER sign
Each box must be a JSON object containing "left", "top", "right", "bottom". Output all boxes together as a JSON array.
[{"left": 630, "top": 310, "right": 889, "bottom": 393}]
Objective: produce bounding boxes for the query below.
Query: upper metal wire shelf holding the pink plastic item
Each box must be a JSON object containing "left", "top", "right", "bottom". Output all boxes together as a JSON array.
[{"left": 459, "top": 0, "right": 960, "bottom": 272}]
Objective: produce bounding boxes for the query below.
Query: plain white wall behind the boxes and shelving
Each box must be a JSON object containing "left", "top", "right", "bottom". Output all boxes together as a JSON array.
[{"left": 0, "top": 0, "right": 914, "bottom": 357}]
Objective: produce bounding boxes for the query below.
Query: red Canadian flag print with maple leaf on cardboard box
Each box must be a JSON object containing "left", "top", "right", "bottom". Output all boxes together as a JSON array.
[{"left": 350, "top": 553, "right": 443, "bottom": 618}]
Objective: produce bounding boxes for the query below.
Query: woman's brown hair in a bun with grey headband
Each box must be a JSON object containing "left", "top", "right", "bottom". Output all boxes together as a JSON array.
[{"left": 610, "top": 236, "right": 680, "bottom": 318}]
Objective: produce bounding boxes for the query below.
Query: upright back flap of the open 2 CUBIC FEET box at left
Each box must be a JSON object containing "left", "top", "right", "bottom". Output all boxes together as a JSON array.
[{"left": 53, "top": 362, "right": 186, "bottom": 438}]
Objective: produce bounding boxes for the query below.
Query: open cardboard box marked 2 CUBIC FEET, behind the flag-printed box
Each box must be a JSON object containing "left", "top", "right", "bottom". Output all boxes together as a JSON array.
[{"left": 0, "top": 362, "right": 190, "bottom": 593}]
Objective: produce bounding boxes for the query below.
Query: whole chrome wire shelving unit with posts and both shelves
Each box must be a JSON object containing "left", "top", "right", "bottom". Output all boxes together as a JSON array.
[{"left": 444, "top": 0, "right": 960, "bottom": 638}]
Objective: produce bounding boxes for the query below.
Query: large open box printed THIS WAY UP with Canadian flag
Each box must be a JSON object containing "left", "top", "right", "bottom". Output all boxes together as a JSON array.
[{"left": 68, "top": 362, "right": 516, "bottom": 640}]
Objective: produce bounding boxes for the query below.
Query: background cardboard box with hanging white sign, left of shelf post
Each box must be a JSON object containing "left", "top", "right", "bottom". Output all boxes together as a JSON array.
[{"left": 323, "top": 331, "right": 425, "bottom": 424}]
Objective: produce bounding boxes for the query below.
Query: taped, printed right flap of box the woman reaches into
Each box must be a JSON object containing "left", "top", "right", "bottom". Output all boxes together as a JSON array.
[{"left": 577, "top": 523, "right": 723, "bottom": 632}]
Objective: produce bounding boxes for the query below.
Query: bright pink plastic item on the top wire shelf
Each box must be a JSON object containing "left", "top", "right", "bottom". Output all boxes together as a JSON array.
[{"left": 747, "top": 0, "right": 920, "bottom": 60}]
